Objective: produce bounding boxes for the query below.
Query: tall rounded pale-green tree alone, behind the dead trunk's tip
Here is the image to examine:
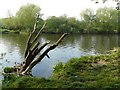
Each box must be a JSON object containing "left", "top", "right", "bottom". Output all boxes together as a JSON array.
[{"left": 16, "top": 4, "right": 42, "bottom": 30}]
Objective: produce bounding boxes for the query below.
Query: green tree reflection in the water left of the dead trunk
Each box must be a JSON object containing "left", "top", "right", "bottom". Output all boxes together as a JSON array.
[{"left": 2, "top": 34, "right": 28, "bottom": 54}]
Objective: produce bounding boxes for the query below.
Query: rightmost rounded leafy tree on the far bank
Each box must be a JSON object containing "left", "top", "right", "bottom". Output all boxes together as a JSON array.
[{"left": 96, "top": 8, "right": 118, "bottom": 32}]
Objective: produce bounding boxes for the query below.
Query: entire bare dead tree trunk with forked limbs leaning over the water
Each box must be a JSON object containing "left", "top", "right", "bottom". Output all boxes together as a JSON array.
[{"left": 20, "top": 15, "right": 67, "bottom": 75}]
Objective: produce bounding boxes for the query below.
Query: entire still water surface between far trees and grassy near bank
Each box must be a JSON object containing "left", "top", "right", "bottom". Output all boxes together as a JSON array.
[{"left": 0, "top": 34, "right": 118, "bottom": 78}]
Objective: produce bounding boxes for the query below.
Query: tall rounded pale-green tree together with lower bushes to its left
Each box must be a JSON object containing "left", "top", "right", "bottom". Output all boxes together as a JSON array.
[{"left": 2, "top": 4, "right": 42, "bottom": 31}]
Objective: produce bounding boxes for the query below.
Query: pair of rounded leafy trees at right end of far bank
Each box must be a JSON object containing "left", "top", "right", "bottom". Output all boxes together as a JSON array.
[{"left": 81, "top": 7, "right": 118, "bottom": 33}]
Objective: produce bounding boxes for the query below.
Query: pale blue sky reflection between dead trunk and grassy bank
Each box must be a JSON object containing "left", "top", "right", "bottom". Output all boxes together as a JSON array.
[{"left": 33, "top": 46, "right": 98, "bottom": 77}]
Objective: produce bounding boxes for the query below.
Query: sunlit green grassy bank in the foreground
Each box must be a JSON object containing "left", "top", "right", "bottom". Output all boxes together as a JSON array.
[{"left": 3, "top": 48, "right": 120, "bottom": 89}]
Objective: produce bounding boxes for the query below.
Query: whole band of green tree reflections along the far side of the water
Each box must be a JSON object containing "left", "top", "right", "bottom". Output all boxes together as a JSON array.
[{"left": 3, "top": 34, "right": 118, "bottom": 55}]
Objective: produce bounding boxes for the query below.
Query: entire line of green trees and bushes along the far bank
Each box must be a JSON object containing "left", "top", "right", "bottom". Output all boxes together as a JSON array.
[{"left": 0, "top": 4, "right": 120, "bottom": 33}]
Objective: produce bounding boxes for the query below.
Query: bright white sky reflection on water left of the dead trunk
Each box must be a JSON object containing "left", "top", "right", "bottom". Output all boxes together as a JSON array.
[{"left": 0, "top": 39, "right": 22, "bottom": 70}]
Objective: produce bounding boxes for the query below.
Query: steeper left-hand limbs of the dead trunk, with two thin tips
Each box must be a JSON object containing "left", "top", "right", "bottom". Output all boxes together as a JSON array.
[{"left": 20, "top": 15, "right": 46, "bottom": 71}]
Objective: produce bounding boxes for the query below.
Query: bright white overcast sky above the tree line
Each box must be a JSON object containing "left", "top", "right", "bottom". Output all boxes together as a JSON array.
[{"left": 0, "top": 0, "right": 116, "bottom": 18}]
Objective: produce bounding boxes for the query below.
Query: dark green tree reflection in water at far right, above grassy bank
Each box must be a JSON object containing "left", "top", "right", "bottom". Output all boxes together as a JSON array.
[{"left": 81, "top": 35, "right": 118, "bottom": 53}]
